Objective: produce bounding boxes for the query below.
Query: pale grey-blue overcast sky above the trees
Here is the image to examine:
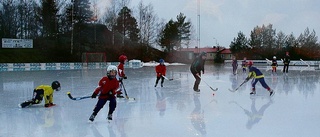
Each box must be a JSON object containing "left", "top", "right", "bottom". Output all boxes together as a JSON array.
[{"left": 97, "top": 0, "right": 320, "bottom": 47}]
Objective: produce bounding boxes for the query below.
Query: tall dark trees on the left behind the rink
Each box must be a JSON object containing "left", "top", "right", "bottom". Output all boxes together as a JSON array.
[{"left": 0, "top": 0, "right": 192, "bottom": 60}]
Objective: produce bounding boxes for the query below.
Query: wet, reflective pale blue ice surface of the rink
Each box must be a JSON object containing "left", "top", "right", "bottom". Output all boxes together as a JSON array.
[{"left": 0, "top": 65, "right": 320, "bottom": 137}]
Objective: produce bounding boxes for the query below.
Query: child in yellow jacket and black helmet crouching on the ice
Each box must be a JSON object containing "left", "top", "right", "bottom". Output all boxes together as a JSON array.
[{"left": 20, "top": 81, "right": 61, "bottom": 108}]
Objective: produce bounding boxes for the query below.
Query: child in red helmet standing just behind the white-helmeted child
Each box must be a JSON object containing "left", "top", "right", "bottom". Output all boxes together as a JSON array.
[{"left": 117, "top": 55, "right": 128, "bottom": 98}]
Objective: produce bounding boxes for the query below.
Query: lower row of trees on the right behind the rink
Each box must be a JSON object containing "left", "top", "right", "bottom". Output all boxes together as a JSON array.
[{"left": 230, "top": 24, "right": 320, "bottom": 60}]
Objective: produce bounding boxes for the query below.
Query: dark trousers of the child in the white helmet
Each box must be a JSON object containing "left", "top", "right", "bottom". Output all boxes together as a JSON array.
[{"left": 93, "top": 97, "right": 117, "bottom": 115}]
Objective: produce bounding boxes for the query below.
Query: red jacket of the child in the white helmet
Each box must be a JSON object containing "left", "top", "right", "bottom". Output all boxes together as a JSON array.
[{"left": 94, "top": 77, "right": 119, "bottom": 99}]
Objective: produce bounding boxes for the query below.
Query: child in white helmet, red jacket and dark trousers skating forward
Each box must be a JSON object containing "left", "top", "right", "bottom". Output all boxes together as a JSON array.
[{"left": 89, "top": 65, "right": 119, "bottom": 121}]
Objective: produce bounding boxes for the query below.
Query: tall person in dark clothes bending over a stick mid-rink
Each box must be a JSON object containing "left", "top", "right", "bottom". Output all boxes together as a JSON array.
[{"left": 190, "top": 52, "right": 207, "bottom": 92}]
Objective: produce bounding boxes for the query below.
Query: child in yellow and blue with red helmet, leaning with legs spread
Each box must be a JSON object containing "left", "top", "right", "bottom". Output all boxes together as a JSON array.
[{"left": 246, "top": 61, "right": 274, "bottom": 96}]
